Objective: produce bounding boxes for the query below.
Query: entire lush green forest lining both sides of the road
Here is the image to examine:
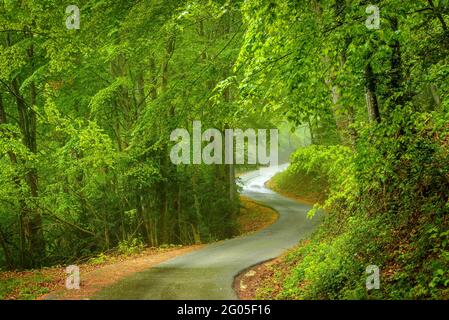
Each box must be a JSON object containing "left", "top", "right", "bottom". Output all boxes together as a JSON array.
[{"left": 0, "top": 0, "right": 449, "bottom": 299}]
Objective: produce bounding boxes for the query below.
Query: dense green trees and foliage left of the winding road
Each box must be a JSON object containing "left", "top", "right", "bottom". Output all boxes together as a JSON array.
[{"left": 0, "top": 0, "right": 243, "bottom": 269}]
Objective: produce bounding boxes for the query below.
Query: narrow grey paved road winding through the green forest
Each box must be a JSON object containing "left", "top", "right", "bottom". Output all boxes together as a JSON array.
[{"left": 94, "top": 165, "right": 320, "bottom": 300}]
